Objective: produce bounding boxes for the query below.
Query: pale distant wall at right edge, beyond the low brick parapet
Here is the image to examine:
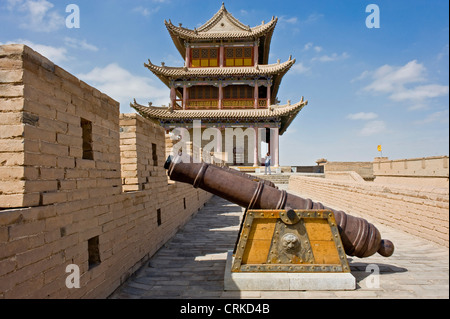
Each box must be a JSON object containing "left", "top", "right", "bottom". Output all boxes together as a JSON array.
[{"left": 373, "top": 156, "right": 449, "bottom": 187}]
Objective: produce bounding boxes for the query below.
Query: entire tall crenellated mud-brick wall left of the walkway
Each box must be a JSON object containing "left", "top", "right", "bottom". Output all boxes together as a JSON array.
[{"left": 0, "top": 45, "right": 212, "bottom": 299}]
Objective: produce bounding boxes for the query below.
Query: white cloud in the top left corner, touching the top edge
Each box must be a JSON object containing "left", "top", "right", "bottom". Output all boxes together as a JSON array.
[{"left": 7, "top": 0, "right": 65, "bottom": 32}]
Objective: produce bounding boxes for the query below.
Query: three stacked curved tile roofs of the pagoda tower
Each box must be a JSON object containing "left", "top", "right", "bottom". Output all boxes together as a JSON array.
[{"left": 135, "top": 4, "right": 308, "bottom": 134}]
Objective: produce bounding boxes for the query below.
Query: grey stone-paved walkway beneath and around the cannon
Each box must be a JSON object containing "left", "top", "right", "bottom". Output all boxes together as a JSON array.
[{"left": 110, "top": 188, "right": 449, "bottom": 299}]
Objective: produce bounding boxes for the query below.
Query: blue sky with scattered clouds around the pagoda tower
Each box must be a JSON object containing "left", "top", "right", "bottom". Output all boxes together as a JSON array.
[{"left": 0, "top": 0, "right": 449, "bottom": 165}]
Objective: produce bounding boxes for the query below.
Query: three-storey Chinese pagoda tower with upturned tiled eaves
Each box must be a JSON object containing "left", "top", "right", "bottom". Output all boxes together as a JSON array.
[{"left": 131, "top": 4, "right": 308, "bottom": 167}]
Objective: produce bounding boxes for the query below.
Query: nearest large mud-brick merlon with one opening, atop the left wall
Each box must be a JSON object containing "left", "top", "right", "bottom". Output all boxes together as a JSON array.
[{"left": 0, "top": 45, "right": 121, "bottom": 208}]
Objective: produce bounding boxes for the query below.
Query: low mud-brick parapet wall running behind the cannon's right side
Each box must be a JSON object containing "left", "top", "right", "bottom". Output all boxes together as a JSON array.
[{"left": 289, "top": 176, "right": 449, "bottom": 247}]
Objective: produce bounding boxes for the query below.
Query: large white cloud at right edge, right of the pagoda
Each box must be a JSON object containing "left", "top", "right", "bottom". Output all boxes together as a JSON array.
[{"left": 361, "top": 60, "right": 449, "bottom": 109}]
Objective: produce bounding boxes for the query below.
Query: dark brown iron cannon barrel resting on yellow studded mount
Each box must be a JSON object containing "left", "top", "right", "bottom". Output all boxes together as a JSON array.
[{"left": 164, "top": 157, "right": 394, "bottom": 258}]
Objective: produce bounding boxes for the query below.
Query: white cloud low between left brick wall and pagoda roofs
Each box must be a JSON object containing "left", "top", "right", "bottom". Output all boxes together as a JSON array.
[{"left": 77, "top": 63, "right": 169, "bottom": 108}]
